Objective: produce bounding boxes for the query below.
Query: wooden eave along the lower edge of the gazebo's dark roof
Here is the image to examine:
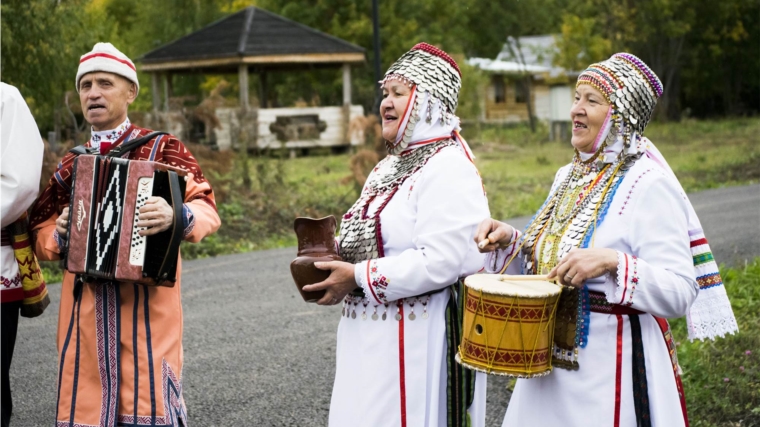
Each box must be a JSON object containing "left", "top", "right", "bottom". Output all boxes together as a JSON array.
[{"left": 145, "top": 53, "right": 365, "bottom": 73}]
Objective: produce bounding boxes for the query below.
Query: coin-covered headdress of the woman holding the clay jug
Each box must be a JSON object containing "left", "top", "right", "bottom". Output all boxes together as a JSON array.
[{"left": 379, "top": 43, "right": 462, "bottom": 154}]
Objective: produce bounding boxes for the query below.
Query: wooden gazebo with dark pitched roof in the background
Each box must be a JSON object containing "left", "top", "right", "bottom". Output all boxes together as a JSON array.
[{"left": 140, "top": 7, "right": 365, "bottom": 152}]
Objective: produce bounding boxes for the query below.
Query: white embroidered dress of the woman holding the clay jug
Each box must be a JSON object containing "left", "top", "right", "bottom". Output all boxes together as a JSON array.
[{"left": 330, "top": 141, "right": 489, "bottom": 427}]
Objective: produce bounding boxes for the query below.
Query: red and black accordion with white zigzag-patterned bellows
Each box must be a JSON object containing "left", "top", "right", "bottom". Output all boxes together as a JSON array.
[{"left": 64, "top": 155, "right": 187, "bottom": 287}]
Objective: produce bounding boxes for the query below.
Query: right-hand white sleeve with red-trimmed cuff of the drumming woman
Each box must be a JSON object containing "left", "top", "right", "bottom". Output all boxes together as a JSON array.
[{"left": 607, "top": 174, "right": 699, "bottom": 318}]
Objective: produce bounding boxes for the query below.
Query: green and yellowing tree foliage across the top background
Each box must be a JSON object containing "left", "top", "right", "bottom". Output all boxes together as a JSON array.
[{"left": 1, "top": 0, "right": 760, "bottom": 133}]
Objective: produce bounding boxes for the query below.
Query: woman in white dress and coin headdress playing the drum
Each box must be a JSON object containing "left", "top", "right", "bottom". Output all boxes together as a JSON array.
[{"left": 475, "top": 53, "right": 737, "bottom": 427}]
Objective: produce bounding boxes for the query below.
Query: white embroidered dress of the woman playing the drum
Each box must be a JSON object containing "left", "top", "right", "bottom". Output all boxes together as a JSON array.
[{"left": 486, "top": 156, "right": 699, "bottom": 427}]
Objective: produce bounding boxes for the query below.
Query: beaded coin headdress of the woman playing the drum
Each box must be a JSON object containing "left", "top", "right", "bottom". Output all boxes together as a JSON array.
[{"left": 576, "top": 53, "right": 662, "bottom": 135}]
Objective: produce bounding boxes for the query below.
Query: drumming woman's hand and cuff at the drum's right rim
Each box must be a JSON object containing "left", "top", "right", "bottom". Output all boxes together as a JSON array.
[{"left": 549, "top": 248, "right": 617, "bottom": 288}]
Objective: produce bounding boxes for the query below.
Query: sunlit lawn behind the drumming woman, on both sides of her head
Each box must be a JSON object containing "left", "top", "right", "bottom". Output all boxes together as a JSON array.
[{"left": 465, "top": 118, "right": 760, "bottom": 219}]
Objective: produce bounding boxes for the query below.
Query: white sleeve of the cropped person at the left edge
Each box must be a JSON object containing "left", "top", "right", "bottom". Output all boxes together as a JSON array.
[{"left": 0, "top": 83, "right": 44, "bottom": 227}]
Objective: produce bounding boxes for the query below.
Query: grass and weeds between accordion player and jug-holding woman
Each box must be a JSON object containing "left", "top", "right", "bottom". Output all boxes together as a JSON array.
[{"left": 182, "top": 145, "right": 361, "bottom": 258}]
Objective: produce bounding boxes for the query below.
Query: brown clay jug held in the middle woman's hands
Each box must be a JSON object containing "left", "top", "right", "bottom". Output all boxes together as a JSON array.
[{"left": 290, "top": 215, "right": 342, "bottom": 302}]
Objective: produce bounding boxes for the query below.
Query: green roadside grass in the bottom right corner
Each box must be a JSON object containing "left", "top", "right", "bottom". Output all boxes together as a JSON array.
[{"left": 671, "top": 258, "right": 760, "bottom": 427}]
